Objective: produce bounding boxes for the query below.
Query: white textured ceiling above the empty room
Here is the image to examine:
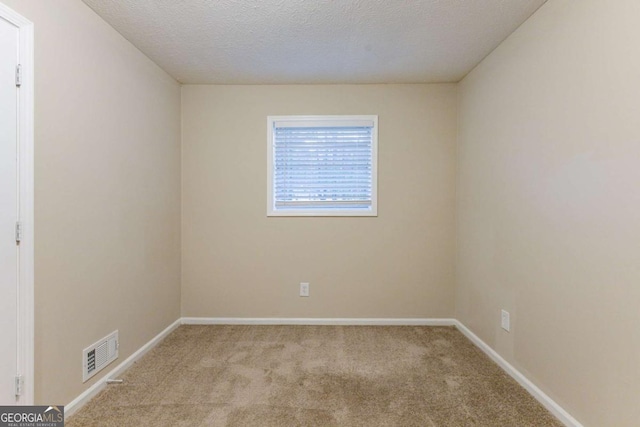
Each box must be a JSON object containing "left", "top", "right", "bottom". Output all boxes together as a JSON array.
[{"left": 83, "top": 0, "right": 546, "bottom": 84}]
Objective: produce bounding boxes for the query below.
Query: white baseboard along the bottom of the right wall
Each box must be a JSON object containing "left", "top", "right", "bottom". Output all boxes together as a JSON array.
[{"left": 455, "top": 320, "right": 582, "bottom": 427}]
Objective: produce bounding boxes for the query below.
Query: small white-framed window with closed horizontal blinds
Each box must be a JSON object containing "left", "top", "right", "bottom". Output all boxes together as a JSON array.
[{"left": 267, "top": 116, "right": 378, "bottom": 216}]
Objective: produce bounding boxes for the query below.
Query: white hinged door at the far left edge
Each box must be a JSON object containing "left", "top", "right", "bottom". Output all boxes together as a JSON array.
[{"left": 0, "top": 18, "right": 19, "bottom": 405}]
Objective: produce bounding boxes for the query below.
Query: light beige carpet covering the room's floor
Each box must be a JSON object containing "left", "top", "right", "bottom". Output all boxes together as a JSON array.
[{"left": 66, "top": 326, "right": 561, "bottom": 427}]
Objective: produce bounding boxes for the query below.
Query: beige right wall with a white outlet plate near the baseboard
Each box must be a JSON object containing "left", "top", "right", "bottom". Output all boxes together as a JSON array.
[{"left": 456, "top": 0, "right": 640, "bottom": 426}]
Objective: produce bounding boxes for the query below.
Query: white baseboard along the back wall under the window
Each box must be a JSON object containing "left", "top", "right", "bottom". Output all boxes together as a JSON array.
[{"left": 182, "top": 317, "right": 457, "bottom": 326}]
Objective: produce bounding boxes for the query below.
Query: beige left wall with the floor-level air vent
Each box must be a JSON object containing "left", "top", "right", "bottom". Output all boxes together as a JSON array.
[{"left": 2, "top": 0, "right": 180, "bottom": 404}]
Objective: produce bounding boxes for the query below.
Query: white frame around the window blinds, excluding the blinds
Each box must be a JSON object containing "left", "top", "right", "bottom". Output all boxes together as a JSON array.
[{"left": 267, "top": 115, "right": 378, "bottom": 216}]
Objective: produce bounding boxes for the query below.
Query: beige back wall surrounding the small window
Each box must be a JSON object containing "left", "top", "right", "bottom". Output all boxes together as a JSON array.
[{"left": 182, "top": 85, "right": 456, "bottom": 318}]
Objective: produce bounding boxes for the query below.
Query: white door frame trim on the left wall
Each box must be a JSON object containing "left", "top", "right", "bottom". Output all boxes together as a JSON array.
[{"left": 0, "top": 3, "right": 35, "bottom": 405}]
